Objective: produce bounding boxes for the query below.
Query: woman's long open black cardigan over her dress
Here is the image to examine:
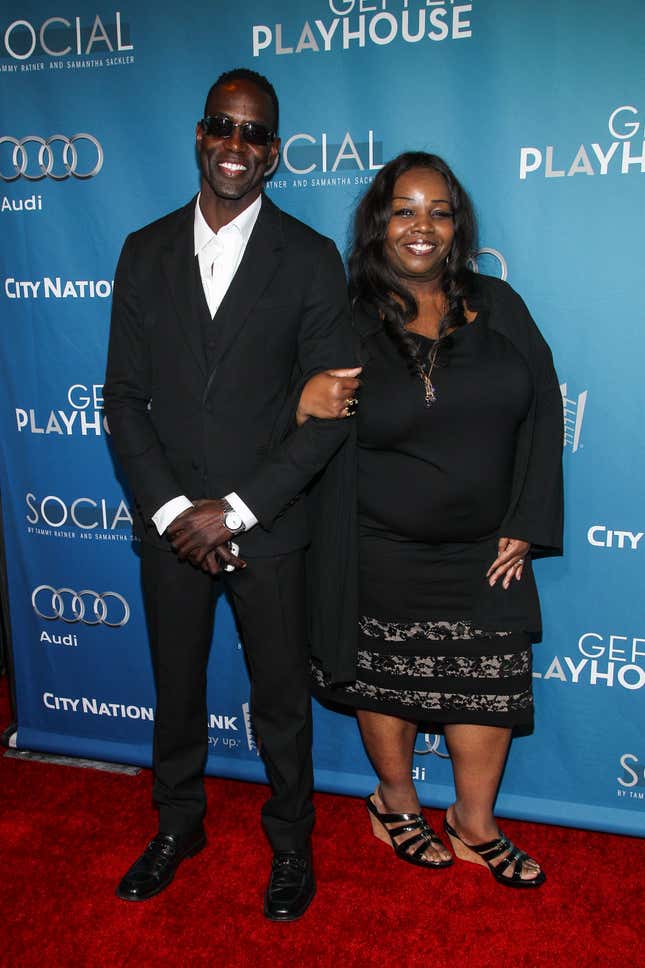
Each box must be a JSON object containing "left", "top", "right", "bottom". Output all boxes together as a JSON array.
[{"left": 307, "top": 274, "right": 563, "bottom": 683}]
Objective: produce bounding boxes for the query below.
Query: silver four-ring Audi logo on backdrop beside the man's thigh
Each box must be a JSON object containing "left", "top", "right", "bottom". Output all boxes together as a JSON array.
[{"left": 31, "top": 585, "right": 130, "bottom": 629}]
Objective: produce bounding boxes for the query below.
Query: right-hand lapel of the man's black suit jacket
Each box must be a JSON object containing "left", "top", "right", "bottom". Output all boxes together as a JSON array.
[{"left": 206, "top": 196, "right": 284, "bottom": 378}]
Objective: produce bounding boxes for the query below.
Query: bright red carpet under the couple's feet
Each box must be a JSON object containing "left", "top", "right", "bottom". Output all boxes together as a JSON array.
[{"left": 0, "top": 681, "right": 645, "bottom": 968}]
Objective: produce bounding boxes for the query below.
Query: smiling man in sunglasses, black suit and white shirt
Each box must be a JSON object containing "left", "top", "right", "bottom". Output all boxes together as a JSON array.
[{"left": 104, "top": 69, "right": 358, "bottom": 921}]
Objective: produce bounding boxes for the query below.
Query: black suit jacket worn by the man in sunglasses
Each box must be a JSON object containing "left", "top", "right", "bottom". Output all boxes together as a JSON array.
[{"left": 104, "top": 197, "right": 354, "bottom": 556}]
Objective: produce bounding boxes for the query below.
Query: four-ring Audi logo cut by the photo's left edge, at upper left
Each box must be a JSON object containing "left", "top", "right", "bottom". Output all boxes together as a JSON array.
[{"left": 0, "top": 134, "right": 103, "bottom": 181}]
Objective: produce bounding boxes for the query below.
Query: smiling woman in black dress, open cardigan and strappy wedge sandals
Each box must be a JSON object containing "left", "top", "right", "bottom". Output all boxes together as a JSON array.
[{"left": 299, "top": 152, "right": 562, "bottom": 887}]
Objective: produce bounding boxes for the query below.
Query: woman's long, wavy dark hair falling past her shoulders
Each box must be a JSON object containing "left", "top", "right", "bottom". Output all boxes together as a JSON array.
[{"left": 349, "top": 151, "right": 477, "bottom": 366}]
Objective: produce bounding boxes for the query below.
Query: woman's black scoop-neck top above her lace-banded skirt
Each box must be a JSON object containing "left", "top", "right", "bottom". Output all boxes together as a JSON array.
[{"left": 356, "top": 313, "right": 533, "bottom": 543}]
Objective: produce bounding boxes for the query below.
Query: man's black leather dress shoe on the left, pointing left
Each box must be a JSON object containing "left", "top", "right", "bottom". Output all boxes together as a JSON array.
[{"left": 116, "top": 827, "right": 206, "bottom": 901}]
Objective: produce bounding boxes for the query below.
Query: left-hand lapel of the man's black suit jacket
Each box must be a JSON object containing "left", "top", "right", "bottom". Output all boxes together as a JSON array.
[{"left": 161, "top": 199, "right": 207, "bottom": 376}]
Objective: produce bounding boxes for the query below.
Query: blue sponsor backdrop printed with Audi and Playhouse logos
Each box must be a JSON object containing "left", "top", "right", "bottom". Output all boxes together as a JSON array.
[{"left": 0, "top": 0, "right": 645, "bottom": 834}]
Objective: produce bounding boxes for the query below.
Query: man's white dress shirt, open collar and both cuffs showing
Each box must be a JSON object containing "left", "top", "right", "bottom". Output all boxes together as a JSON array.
[{"left": 152, "top": 195, "right": 262, "bottom": 534}]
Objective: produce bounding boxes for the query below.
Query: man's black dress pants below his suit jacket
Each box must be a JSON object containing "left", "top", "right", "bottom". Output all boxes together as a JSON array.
[{"left": 142, "top": 542, "right": 314, "bottom": 850}]
